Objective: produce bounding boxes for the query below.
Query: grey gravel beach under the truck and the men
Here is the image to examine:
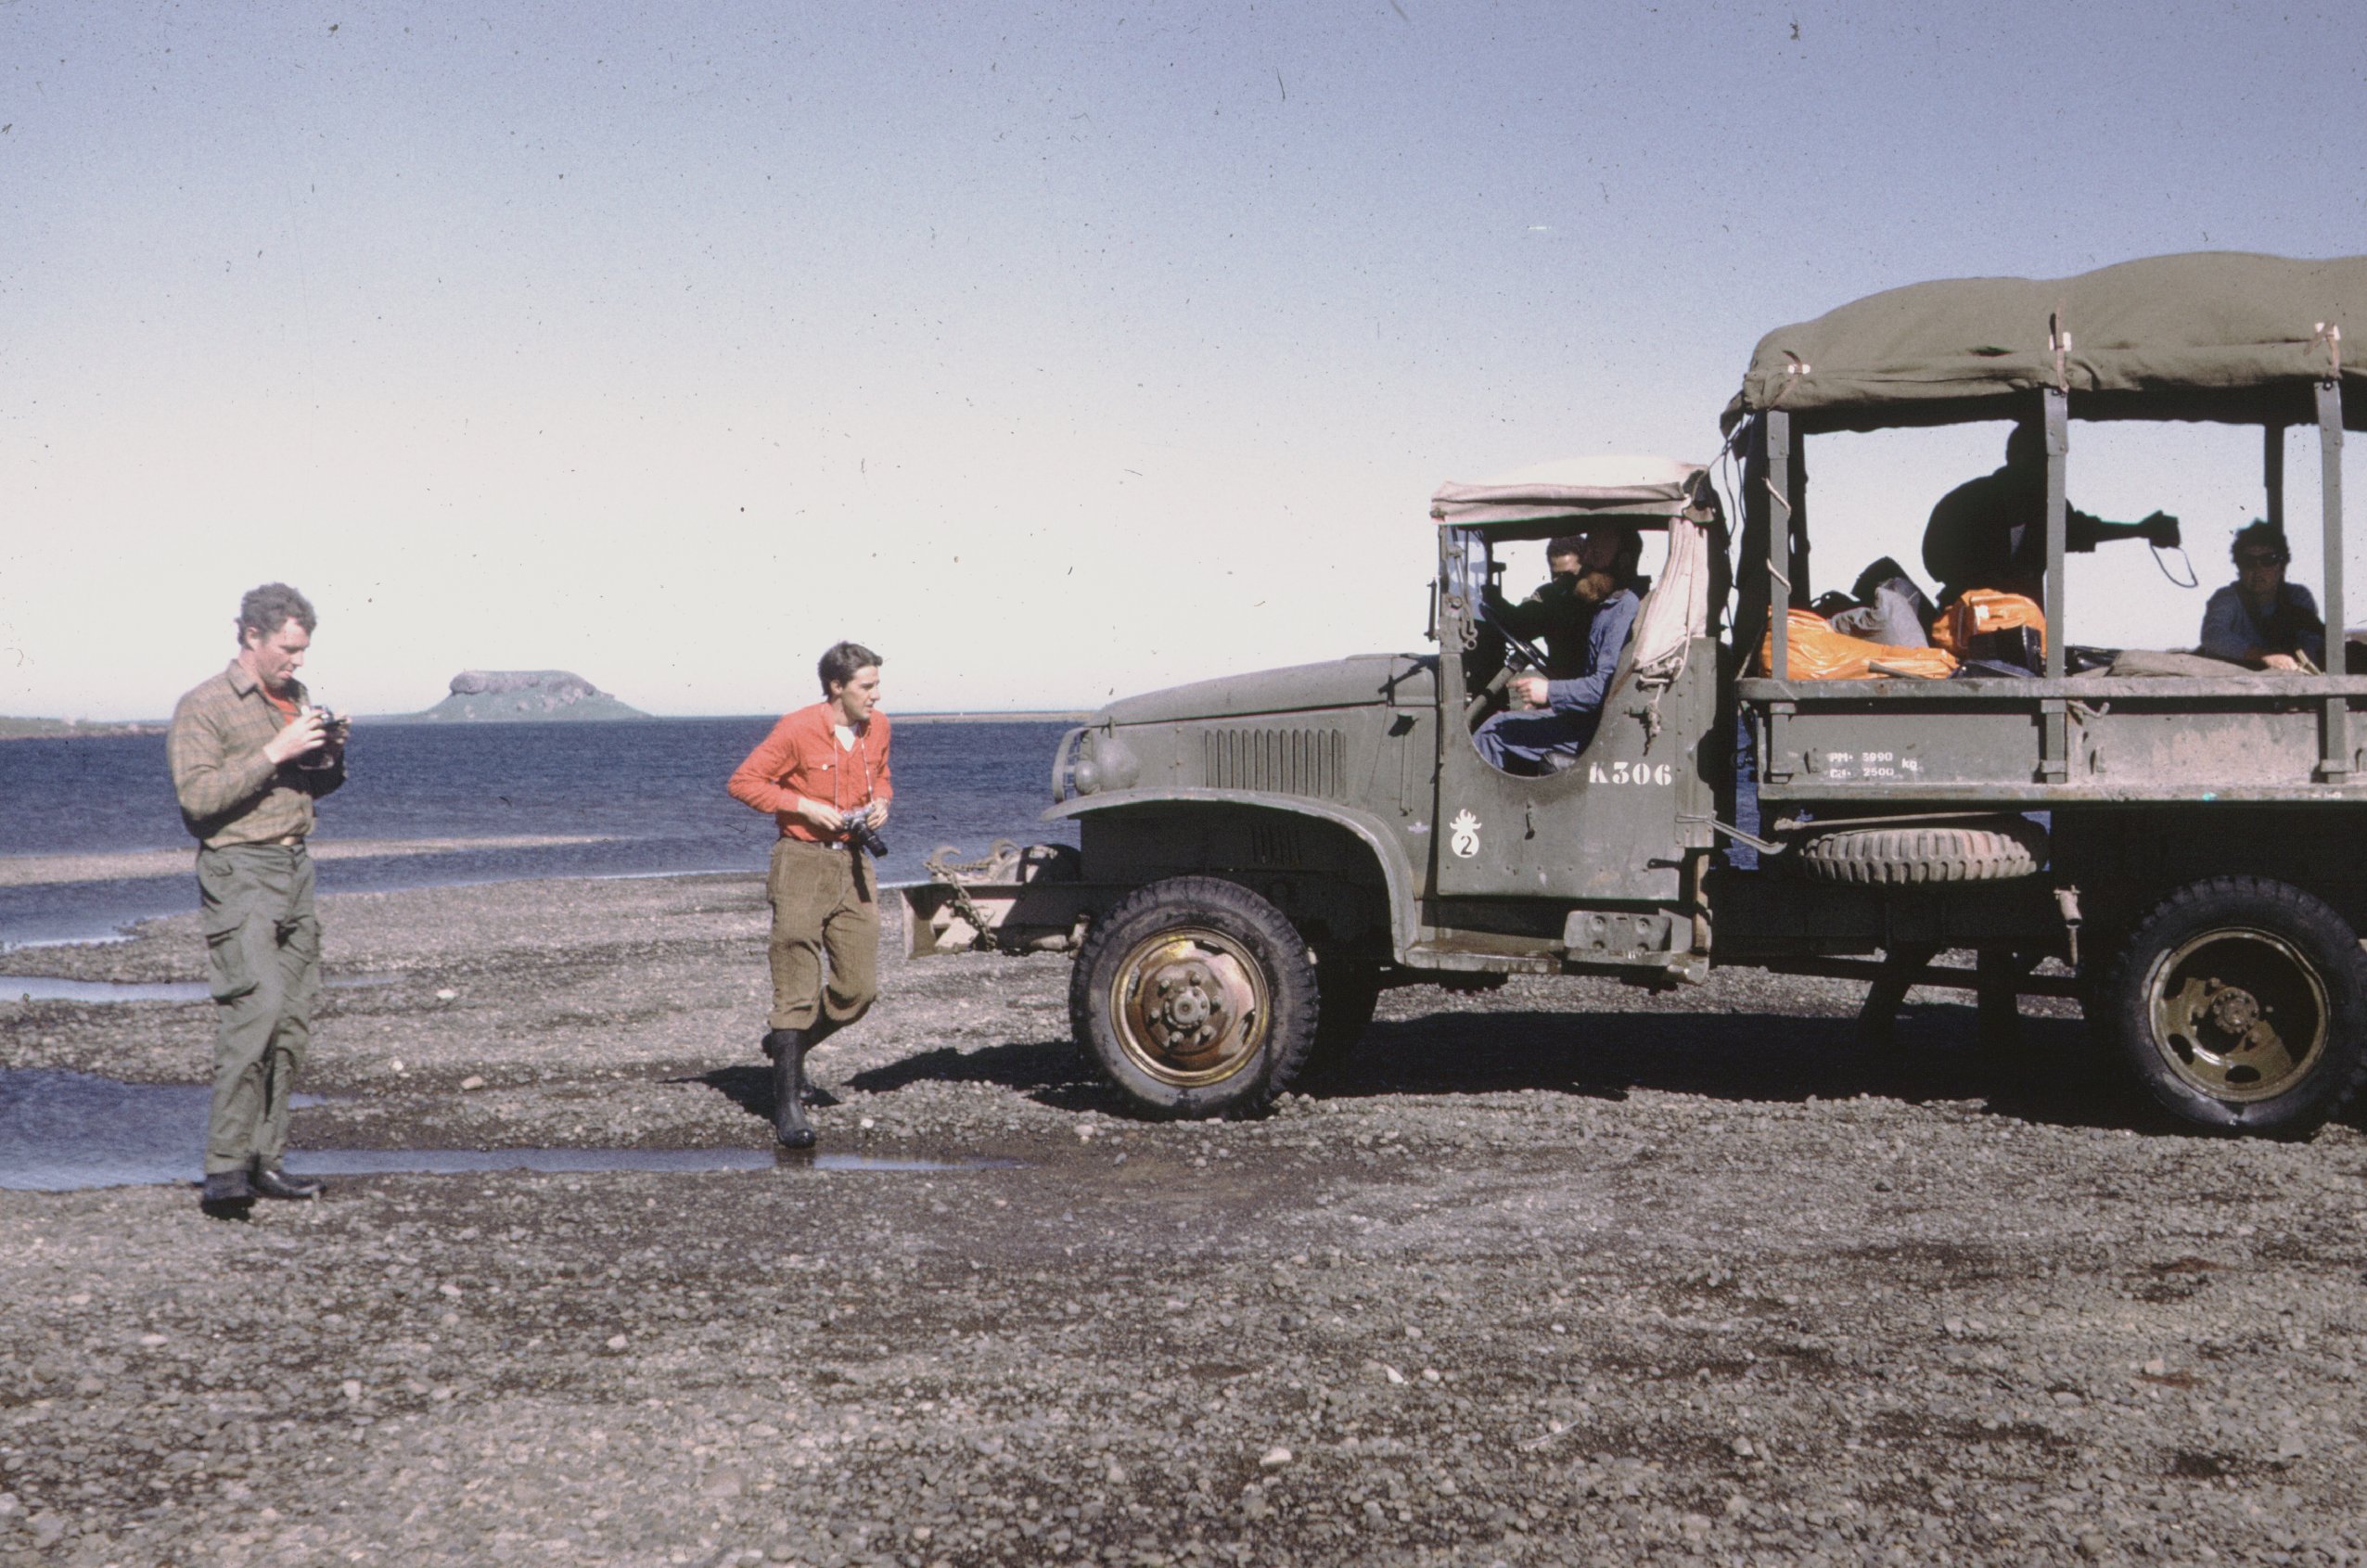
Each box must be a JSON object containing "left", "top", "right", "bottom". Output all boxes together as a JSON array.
[{"left": 0, "top": 875, "right": 2367, "bottom": 1568}]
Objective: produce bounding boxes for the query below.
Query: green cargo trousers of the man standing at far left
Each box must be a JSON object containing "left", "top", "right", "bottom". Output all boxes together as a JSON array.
[{"left": 197, "top": 845, "right": 320, "bottom": 1176}]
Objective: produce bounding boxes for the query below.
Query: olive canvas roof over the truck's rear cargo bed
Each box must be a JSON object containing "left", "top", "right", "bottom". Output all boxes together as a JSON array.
[{"left": 1723, "top": 250, "right": 2367, "bottom": 433}]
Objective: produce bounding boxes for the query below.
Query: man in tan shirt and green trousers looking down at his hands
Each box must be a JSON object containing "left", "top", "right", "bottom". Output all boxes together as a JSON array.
[{"left": 166, "top": 581, "right": 346, "bottom": 1216}]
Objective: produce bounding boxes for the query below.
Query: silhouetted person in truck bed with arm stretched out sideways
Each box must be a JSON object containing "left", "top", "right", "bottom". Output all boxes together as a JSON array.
[{"left": 1925, "top": 421, "right": 2178, "bottom": 610}]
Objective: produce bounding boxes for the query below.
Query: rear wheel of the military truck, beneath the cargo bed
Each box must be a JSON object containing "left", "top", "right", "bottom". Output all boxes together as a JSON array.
[{"left": 2095, "top": 877, "right": 2367, "bottom": 1138}]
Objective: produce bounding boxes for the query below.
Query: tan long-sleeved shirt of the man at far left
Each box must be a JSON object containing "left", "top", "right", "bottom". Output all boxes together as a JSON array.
[{"left": 166, "top": 660, "right": 346, "bottom": 849}]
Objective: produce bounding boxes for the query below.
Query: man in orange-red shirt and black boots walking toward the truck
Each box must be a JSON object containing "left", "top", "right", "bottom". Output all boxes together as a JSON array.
[{"left": 729, "top": 644, "right": 895, "bottom": 1150}]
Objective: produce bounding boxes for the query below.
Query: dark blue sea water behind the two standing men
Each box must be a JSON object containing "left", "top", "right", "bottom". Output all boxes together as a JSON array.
[{"left": 0, "top": 714, "right": 1077, "bottom": 946}]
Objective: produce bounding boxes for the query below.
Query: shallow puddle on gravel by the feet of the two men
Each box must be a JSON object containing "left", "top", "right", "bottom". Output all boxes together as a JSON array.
[{"left": 0, "top": 1069, "right": 1017, "bottom": 1192}]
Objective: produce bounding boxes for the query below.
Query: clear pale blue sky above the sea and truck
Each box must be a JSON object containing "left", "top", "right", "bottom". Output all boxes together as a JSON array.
[{"left": 0, "top": 0, "right": 2367, "bottom": 717}]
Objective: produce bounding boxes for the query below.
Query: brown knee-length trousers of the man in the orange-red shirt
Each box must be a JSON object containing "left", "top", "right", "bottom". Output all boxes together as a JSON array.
[{"left": 764, "top": 837, "right": 880, "bottom": 1028}]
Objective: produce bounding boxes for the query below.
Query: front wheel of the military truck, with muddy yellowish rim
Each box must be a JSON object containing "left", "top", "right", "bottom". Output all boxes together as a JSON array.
[{"left": 1068, "top": 877, "right": 1316, "bottom": 1118}]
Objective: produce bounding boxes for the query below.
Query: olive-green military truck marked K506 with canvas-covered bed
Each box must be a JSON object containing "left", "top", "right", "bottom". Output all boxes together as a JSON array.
[{"left": 909, "top": 253, "right": 2367, "bottom": 1135}]
